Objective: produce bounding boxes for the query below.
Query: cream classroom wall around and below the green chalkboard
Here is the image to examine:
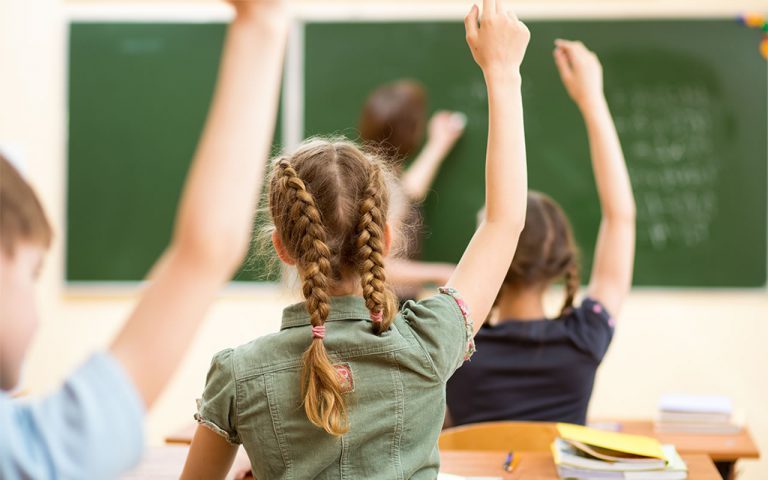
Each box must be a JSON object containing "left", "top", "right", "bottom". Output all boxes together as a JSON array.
[{"left": 0, "top": 0, "right": 768, "bottom": 480}]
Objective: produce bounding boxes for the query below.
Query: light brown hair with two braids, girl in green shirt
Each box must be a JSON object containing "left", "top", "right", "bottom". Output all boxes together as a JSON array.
[{"left": 268, "top": 140, "right": 397, "bottom": 435}]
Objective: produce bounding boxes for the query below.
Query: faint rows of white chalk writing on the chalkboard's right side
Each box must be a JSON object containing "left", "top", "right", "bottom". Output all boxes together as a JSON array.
[{"left": 608, "top": 83, "right": 722, "bottom": 250}]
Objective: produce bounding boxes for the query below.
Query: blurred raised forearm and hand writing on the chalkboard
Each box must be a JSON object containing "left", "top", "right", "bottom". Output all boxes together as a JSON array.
[{"left": 401, "top": 112, "right": 467, "bottom": 202}]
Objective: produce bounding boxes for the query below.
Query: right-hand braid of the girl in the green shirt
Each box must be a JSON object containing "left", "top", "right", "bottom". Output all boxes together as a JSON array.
[{"left": 356, "top": 163, "right": 396, "bottom": 333}]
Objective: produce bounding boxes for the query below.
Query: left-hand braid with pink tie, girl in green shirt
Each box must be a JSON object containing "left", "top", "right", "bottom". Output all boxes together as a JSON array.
[{"left": 277, "top": 160, "right": 349, "bottom": 435}]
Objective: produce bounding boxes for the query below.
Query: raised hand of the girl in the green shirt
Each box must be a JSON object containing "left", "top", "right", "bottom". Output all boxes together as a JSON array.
[{"left": 464, "top": 0, "right": 531, "bottom": 77}]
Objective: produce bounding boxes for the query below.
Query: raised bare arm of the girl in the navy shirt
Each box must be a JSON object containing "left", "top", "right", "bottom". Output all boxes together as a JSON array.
[{"left": 554, "top": 40, "right": 635, "bottom": 317}]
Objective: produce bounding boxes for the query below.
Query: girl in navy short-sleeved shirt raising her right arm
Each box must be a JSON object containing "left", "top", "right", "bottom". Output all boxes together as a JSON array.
[{"left": 447, "top": 40, "right": 635, "bottom": 425}]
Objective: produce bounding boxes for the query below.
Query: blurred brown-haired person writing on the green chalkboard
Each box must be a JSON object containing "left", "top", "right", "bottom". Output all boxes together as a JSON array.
[{"left": 358, "top": 80, "right": 466, "bottom": 299}]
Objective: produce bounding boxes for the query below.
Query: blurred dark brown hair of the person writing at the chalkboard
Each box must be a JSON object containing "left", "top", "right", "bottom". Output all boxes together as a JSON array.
[{"left": 358, "top": 80, "right": 427, "bottom": 161}]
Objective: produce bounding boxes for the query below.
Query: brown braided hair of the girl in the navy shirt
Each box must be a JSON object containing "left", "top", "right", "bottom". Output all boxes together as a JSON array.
[{"left": 499, "top": 191, "right": 579, "bottom": 315}]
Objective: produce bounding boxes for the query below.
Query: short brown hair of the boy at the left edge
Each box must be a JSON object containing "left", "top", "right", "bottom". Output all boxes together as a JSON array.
[{"left": 0, "top": 154, "right": 53, "bottom": 256}]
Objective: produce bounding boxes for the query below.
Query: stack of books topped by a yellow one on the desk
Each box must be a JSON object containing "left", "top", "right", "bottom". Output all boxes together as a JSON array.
[{"left": 552, "top": 424, "right": 688, "bottom": 480}]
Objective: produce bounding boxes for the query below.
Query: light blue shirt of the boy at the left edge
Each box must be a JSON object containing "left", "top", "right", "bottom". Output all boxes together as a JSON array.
[{"left": 0, "top": 353, "right": 145, "bottom": 480}]
